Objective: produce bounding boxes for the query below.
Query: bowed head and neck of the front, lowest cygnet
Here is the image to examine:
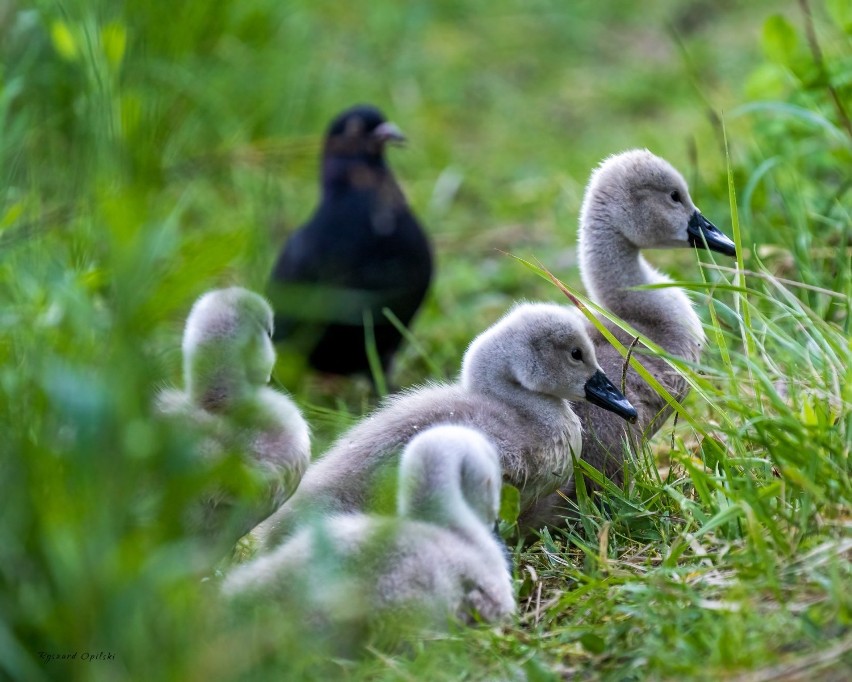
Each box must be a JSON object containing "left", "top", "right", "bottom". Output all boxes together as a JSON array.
[{"left": 398, "top": 424, "right": 502, "bottom": 527}]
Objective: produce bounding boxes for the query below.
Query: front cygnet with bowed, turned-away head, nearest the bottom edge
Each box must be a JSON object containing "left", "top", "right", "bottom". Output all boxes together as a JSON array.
[{"left": 223, "top": 425, "right": 515, "bottom": 637}]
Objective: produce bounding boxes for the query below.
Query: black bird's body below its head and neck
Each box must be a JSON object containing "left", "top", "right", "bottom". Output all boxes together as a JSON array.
[{"left": 270, "top": 171, "right": 432, "bottom": 374}]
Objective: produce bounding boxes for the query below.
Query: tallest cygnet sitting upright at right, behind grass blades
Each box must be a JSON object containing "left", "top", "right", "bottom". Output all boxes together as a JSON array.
[{"left": 521, "top": 149, "right": 736, "bottom": 529}]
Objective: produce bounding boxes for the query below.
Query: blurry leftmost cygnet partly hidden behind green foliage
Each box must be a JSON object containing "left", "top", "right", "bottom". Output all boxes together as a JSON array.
[{"left": 156, "top": 287, "right": 310, "bottom": 540}]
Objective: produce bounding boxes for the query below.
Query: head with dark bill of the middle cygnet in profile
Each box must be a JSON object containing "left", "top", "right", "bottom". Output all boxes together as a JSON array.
[{"left": 461, "top": 303, "right": 636, "bottom": 421}]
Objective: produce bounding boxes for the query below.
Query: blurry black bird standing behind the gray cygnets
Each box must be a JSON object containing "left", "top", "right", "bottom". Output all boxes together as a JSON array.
[{"left": 269, "top": 105, "right": 432, "bottom": 382}]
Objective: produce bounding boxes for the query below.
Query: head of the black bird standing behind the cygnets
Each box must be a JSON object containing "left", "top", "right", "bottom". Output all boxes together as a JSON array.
[{"left": 325, "top": 104, "right": 405, "bottom": 163}]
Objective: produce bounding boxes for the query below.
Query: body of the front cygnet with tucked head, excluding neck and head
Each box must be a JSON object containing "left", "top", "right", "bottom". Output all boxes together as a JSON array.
[{"left": 230, "top": 514, "right": 515, "bottom": 628}]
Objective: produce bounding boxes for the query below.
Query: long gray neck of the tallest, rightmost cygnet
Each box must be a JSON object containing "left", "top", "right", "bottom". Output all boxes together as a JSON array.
[{"left": 580, "top": 215, "right": 704, "bottom": 359}]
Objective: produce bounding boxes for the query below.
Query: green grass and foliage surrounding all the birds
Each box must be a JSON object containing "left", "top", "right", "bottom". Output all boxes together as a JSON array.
[{"left": 0, "top": 0, "right": 852, "bottom": 680}]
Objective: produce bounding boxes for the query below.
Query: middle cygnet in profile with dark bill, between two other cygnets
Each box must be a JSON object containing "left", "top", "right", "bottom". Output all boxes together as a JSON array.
[{"left": 255, "top": 303, "right": 636, "bottom": 546}]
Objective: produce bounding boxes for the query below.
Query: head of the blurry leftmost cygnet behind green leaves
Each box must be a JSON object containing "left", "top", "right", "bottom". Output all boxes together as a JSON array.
[{"left": 183, "top": 287, "right": 275, "bottom": 407}]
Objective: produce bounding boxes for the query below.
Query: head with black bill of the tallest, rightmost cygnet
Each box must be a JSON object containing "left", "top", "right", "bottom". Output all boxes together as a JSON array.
[{"left": 580, "top": 149, "right": 736, "bottom": 256}]
